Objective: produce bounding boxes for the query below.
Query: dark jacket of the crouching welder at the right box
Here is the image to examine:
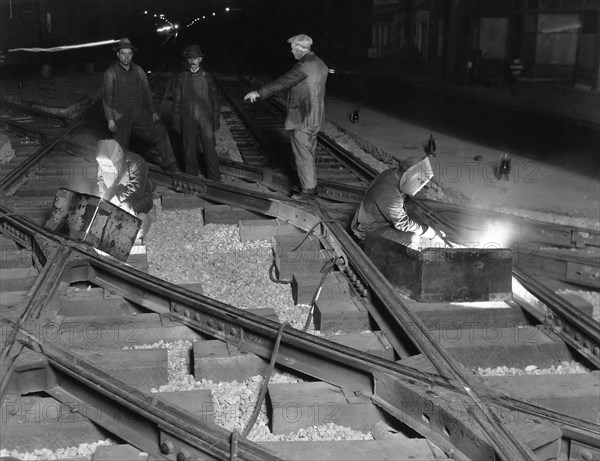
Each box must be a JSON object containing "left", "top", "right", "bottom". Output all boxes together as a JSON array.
[{"left": 352, "top": 168, "right": 427, "bottom": 238}]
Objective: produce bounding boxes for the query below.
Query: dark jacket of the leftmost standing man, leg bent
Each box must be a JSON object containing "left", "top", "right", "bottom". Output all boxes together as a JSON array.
[{"left": 102, "top": 62, "right": 156, "bottom": 121}]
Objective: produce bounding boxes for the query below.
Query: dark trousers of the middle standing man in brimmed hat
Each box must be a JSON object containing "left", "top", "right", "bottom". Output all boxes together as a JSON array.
[{"left": 181, "top": 118, "right": 221, "bottom": 181}]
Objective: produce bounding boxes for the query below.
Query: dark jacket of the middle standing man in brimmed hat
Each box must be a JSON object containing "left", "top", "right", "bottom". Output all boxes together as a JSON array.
[{"left": 173, "top": 68, "right": 221, "bottom": 129}]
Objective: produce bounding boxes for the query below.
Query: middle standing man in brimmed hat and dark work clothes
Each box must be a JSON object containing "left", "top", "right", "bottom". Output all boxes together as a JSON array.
[{"left": 173, "top": 45, "right": 221, "bottom": 181}]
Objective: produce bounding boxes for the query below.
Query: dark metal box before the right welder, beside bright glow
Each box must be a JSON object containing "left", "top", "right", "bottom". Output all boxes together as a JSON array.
[{"left": 364, "top": 233, "right": 513, "bottom": 302}]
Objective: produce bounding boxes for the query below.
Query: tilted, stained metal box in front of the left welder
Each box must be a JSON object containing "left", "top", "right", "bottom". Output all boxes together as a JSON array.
[{"left": 44, "top": 187, "right": 142, "bottom": 261}]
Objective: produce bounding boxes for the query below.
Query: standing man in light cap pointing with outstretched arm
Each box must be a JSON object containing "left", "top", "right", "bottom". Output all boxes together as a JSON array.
[{"left": 244, "top": 34, "right": 329, "bottom": 199}]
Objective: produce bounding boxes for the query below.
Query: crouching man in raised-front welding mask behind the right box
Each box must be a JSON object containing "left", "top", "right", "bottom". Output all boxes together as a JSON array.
[{"left": 351, "top": 157, "right": 445, "bottom": 249}]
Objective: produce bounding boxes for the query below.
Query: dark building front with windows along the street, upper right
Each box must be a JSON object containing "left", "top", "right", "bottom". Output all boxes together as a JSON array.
[{"left": 369, "top": 0, "right": 600, "bottom": 90}]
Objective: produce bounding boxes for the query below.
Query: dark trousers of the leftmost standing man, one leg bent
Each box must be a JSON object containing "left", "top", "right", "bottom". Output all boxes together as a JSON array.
[{"left": 113, "top": 112, "right": 177, "bottom": 168}]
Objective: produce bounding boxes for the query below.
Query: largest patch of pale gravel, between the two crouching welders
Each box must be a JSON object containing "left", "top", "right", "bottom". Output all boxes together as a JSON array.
[{"left": 146, "top": 201, "right": 309, "bottom": 328}]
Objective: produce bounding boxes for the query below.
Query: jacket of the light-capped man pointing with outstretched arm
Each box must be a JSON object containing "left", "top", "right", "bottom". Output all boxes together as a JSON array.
[{"left": 258, "top": 51, "right": 329, "bottom": 130}]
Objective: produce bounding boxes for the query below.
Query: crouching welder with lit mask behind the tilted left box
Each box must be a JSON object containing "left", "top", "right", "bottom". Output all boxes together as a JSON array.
[{"left": 96, "top": 139, "right": 154, "bottom": 238}]
